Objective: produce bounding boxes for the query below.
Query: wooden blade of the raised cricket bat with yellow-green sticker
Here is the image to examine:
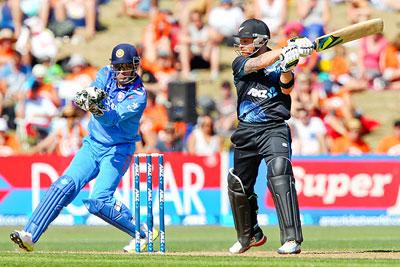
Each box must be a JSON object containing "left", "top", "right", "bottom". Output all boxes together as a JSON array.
[{"left": 314, "top": 18, "right": 383, "bottom": 52}]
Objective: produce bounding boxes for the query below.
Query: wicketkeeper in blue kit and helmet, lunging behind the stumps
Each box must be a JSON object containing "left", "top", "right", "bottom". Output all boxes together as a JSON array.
[{"left": 10, "top": 44, "right": 158, "bottom": 252}]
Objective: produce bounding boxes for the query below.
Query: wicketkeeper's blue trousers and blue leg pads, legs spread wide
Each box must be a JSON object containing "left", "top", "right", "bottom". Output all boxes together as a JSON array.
[{"left": 24, "top": 137, "right": 138, "bottom": 242}]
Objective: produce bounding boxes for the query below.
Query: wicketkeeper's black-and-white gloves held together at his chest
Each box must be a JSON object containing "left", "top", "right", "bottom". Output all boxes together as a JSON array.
[{"left": 74, "top": 87, "right": 108, "bottom": 116}]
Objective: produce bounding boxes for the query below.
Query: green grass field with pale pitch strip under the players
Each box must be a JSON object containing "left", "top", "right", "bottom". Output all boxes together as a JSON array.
[{"left": 0, "top": 226, "right": 400, "bottom": 267}]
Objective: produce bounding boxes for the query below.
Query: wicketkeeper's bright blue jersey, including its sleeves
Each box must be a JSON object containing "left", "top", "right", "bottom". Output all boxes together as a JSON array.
[{"left": 88, "top": 66, "right": 147, "bottom": 147}]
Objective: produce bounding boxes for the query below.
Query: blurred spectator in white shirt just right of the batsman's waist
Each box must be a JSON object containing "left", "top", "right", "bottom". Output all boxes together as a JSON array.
[{"left": 291, "top": 108, "right": 328, "bottom": 155}]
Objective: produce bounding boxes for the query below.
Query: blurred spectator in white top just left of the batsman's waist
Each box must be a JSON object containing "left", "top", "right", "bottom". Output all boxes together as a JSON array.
[{"left": 187, "top": 115, "right": 222, "bottom": 156}]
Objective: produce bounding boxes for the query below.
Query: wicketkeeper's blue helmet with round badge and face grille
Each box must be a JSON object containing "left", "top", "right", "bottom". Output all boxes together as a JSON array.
[{"left": 110, "top": 44, "right": 140, "bottom": 85}]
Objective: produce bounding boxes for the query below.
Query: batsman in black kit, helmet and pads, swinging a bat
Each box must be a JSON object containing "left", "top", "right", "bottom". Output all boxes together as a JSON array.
[{"left": 228, "top": 19, "right": 313, "bottom": 254}]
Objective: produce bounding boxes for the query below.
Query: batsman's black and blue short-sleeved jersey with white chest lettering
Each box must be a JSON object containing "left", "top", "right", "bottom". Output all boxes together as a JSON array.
[{"left": 232, "top": 56, "right": 291, "bottom": 124}]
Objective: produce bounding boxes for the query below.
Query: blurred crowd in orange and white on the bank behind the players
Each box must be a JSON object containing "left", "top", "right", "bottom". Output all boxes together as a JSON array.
[{"left": 0, "top": 0, "right": 400, "bottom": 156}]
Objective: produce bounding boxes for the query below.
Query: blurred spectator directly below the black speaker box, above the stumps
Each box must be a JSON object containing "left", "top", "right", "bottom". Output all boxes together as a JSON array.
[{"left": 155, "top": 123, "right": 183, "bottom": 152}]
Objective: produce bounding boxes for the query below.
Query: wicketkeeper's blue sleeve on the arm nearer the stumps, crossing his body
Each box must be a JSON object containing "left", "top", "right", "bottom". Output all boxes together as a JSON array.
[{"left": 95, "top": 89, "right": 147, "bottom": 126}]
